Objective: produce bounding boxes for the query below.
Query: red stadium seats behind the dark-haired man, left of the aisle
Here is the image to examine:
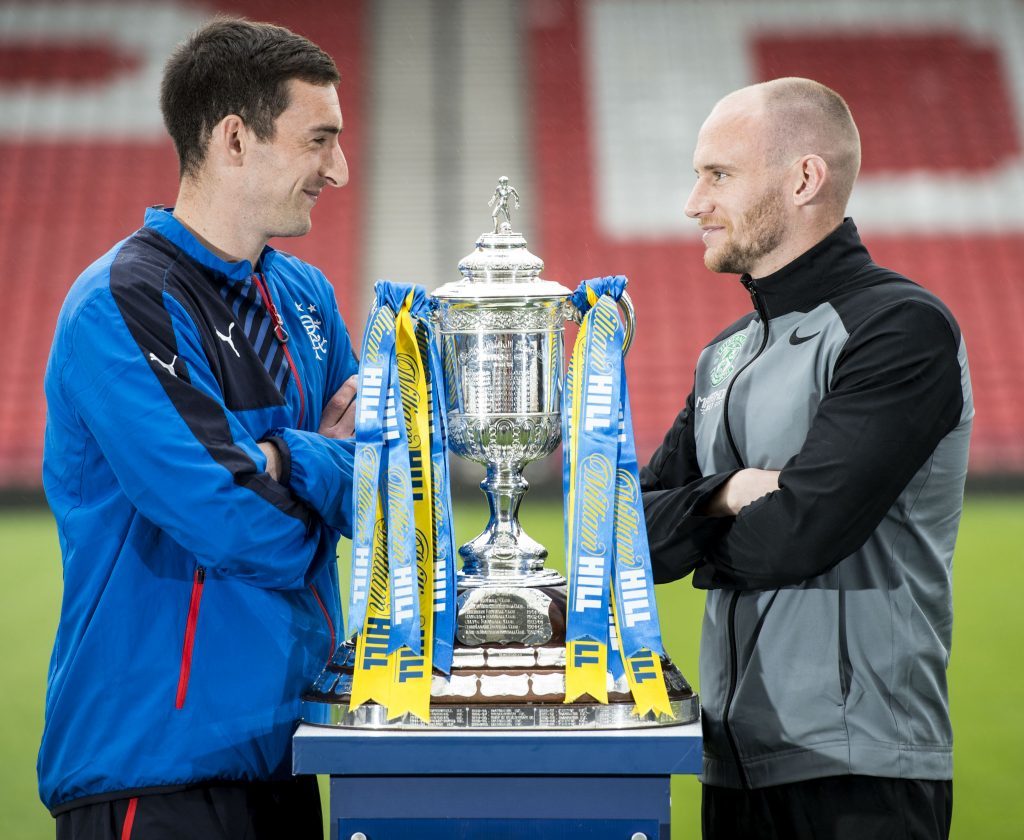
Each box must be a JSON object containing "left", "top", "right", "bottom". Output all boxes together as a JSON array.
[{"left": 0, "top": 0, "right": 364, "bottom": 489}]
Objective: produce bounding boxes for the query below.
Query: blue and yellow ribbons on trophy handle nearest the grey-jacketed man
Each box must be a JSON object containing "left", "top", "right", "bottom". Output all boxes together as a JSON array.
[{"left": 563, "top": 277, "right": 673, "bottom": 716}]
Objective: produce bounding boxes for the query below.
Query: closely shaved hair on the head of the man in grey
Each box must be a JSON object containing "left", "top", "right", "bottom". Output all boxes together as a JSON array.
[{"left": 733, "top": 77, "right": 860, "bottom": 208}]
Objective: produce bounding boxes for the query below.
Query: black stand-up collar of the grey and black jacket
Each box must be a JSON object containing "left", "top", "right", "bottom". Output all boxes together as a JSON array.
[{"left": 740, "top": 218, "right": 871, "bottom": 319}]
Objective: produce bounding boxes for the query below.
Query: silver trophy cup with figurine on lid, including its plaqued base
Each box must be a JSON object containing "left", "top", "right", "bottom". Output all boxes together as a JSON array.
[{"left": 306, "top": 177, "right": 699, "bottom": 728}]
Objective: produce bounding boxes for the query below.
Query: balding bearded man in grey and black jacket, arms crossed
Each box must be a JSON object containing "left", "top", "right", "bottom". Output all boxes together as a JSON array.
[{"left": 641, "top": 79, "right": 974, "bottom": 840}]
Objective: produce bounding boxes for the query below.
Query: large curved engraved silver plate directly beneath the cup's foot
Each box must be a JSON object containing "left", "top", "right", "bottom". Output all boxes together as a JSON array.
[{"left": 456, "top": 587, "right": 553, "bottom": 644}]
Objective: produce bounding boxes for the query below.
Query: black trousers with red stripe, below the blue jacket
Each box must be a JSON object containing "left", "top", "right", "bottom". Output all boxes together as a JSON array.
[{"left": 57, "top": 775, "right": 324, "bottom": 840}]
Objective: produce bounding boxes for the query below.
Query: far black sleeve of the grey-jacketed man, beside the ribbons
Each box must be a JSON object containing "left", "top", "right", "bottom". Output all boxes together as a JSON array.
[{"left": 640, "top": 391, "right": 732, "bottom": 583}]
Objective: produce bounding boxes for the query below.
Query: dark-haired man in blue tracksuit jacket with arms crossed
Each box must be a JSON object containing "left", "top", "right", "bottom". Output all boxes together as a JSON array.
[{"left": 38, "top": 18, "right": 356, "bottom": 840}]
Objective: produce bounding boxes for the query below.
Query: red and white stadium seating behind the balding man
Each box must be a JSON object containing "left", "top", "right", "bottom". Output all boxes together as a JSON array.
[{"left": 529, "top": 0, "right": 1024, "bottom": 475}]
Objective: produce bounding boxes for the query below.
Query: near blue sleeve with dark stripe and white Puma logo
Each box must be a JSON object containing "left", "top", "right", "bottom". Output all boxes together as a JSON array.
[{"left": 61, "top": 289, "right": 321, "bottom": 589}]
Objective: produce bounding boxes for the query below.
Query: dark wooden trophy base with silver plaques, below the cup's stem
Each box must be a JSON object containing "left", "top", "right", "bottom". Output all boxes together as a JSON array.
[{"left": 302, "top": 581, "right": 700, "bottom": 729}]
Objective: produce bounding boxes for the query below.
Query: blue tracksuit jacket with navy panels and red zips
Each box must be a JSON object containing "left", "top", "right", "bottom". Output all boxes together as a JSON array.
[{"left": 38, "top": 209, "right": 356, "bottom": 812}]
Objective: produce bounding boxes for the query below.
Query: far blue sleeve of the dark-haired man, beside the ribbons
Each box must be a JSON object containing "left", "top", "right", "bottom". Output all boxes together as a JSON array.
[{"left": 267, "top": 275, "right": 358, "bottom": 537}]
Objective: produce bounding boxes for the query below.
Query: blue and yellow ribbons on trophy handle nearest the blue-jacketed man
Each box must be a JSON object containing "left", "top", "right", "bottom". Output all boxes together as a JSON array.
[{"left": 349, "top": 281, "right": 455, "bottom": 720}]
